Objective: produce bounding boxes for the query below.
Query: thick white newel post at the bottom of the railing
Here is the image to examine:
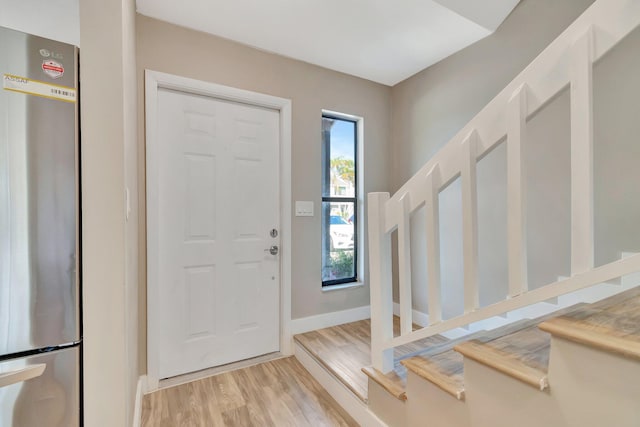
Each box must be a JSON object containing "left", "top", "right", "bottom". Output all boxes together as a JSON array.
[{"left": 367, "top": 193, "right": 393, "bottom": 373}]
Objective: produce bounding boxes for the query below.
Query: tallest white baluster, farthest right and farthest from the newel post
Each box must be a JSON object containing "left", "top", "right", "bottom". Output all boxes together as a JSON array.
[{"left": 570, "top": 27, "right": 593, "bottom": 275}]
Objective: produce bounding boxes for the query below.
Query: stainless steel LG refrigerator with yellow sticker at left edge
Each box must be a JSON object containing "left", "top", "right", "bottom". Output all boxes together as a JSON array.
[{"left": 0, "top": 25, "right": 82, "bottom": 427}]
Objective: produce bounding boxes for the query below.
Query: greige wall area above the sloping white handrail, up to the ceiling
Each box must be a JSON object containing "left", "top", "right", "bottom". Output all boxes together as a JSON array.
[{"left": 392, "top": 0, "right": 594, "bottom": 189}]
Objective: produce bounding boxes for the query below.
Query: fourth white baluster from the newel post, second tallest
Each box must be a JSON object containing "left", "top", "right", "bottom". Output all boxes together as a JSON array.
[{"left": 507, "top": 84, "right": 528, "bottom": 297}]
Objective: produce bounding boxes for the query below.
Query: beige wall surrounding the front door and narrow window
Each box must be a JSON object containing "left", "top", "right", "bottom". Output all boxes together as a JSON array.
[{"left": 137, "top": 15, "right": 390, "bottom": 370}]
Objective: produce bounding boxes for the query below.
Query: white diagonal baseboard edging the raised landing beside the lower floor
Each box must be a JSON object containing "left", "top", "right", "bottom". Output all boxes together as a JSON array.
[{"left": 295, "top": 344, "right": 387, "bottom": 427}]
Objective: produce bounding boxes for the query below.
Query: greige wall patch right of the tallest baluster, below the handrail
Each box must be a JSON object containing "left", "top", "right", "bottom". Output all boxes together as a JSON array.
[{"left": 593, "top": 28, "right": 640, "bottom": 265}]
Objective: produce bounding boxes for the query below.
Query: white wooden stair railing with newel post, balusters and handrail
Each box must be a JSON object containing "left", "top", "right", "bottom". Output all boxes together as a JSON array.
[{"left": 368, "top": 0, "right": 640, "bottom": 372}]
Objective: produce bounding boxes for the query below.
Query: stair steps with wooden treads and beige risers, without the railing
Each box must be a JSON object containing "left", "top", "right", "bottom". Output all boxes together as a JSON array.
[{"left": 362, "top": 288, "right": 640, "bottom": 427}]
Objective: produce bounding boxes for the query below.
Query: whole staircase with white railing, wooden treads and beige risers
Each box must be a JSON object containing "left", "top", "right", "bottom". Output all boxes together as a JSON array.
[{"left": 364, "top": 0, "right": 640, "bottom": 427}]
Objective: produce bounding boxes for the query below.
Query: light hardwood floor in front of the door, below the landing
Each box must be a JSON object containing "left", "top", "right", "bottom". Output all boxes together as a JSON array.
[{"left": 142, "top": 357, "right": 358, "bottom": 427}]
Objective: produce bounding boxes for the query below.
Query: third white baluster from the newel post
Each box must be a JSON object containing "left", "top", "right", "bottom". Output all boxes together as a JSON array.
[{"left": 460, "top": 129, "right": 479, "bottom": 313}]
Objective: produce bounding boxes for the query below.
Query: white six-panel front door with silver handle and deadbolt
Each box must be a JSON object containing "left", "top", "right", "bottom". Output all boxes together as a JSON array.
[{"left": 148, "top": 88, "right": 280, "bottom": 378}]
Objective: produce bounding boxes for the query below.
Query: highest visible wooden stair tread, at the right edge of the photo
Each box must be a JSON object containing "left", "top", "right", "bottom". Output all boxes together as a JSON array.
[{"left": 540, "top": 287, "right": 640, "bottom": 360}]
